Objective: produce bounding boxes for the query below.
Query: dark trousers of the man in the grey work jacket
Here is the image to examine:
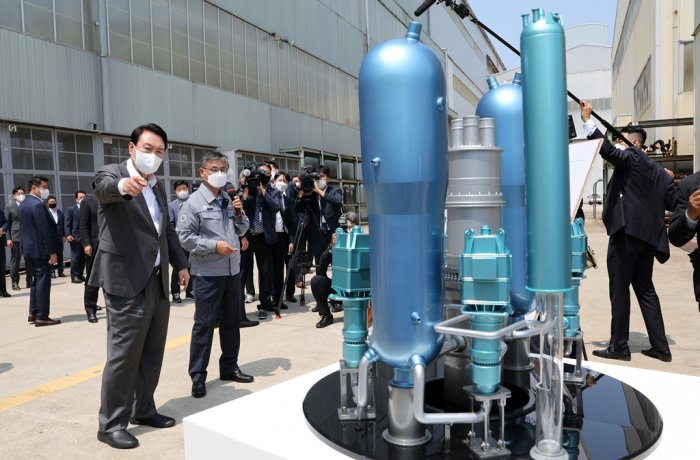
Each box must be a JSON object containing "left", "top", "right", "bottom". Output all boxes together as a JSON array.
[{"left": 189, "top": 273, "right": 241, "bottom": 382}]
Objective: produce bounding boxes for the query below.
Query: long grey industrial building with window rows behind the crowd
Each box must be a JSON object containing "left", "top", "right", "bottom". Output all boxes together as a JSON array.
[{"left": 0, "top": 0, "right": 504, "bottom": 223}]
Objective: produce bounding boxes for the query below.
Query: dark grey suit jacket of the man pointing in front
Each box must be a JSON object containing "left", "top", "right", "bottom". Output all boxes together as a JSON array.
[{"left": 89, "top": 159, "right": 187, "bottom": 297}]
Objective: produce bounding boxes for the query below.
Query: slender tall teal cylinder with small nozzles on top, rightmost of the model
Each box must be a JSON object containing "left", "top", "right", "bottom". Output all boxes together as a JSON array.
[{"left": 520, "top": 8, "right": 571, "bottom": 292}]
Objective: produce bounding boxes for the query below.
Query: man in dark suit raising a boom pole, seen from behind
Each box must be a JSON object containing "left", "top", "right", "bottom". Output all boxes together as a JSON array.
[{"left": 581, "top": 101, "right": 675, "bottom": 362}]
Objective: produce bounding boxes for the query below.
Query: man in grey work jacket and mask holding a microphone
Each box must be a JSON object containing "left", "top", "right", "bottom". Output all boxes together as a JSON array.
[{"left": 176, "top": 152, "right": 253, "bottom": 398}]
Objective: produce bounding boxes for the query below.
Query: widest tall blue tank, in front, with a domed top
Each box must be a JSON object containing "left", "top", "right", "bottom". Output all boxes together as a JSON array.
[{"left": 359, "top": 22, "right": 448, "bottom": 369}]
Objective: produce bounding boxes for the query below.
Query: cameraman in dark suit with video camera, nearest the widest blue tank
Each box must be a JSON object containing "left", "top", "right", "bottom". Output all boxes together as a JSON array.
[{"left": 296, "top": 165, "right": 343, "bottom": 265}]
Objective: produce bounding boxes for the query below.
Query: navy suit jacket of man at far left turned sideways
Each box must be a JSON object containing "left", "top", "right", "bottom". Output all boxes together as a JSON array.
[{"left": 19, "top": 195, "right": 59, "bottom": 258}]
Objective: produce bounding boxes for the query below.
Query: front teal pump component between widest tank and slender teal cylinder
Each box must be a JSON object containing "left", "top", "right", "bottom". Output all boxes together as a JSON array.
[{"left": 460, "top": 225, "right": 512, "bottom": 393}]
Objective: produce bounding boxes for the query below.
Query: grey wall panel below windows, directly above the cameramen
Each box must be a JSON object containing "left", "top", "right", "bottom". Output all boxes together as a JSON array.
[{"left": 270, "top": 107, "right": 323, "bottom": 153}]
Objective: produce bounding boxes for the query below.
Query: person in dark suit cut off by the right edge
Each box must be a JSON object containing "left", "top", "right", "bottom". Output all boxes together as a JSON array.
[{"left": 668, "top": 172, "right": 700, "bottom": 307}]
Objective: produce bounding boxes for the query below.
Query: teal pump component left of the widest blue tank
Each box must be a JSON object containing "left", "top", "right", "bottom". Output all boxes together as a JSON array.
[{"left": 329, "top": 225, "right": 372, "bottom": 369}]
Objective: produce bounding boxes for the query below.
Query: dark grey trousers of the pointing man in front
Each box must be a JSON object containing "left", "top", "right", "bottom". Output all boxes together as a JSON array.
[{"left": 99, "top": 274, "right": 170, "bottom": 433}]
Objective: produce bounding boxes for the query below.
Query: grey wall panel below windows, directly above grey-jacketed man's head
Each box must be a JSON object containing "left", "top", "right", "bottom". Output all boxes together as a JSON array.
[{"left": 193, "top": 83, "right": 276, "bottom": 153}]
